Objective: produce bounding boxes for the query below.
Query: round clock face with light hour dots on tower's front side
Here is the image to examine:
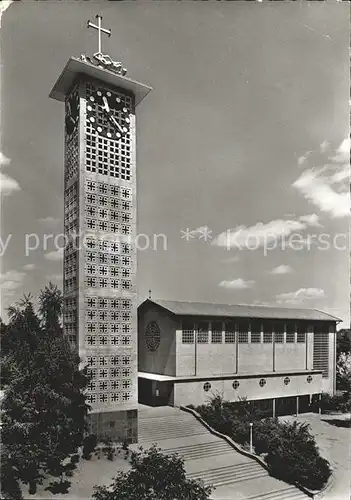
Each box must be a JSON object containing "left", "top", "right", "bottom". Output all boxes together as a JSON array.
[{"left": 86, "top": 90, "right": 130, "bottom": 140}]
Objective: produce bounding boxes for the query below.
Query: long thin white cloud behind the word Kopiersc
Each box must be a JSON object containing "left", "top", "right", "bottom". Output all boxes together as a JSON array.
[{"left": 212, "top": 214, "right": 318, "bottom": 250}]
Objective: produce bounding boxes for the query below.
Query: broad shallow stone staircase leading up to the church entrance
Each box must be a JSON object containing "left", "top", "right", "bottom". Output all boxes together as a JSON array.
[{"left": 135, "top": 405, "right": 309, "bottom": 500}]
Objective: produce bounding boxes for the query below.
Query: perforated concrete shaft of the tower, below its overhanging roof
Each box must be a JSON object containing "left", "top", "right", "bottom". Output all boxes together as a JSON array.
[{"left": 64, "top": 76, "right": 138, "bottom": 438}]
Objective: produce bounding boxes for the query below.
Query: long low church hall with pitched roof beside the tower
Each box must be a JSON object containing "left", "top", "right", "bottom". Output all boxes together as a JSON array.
[{"left": 138, "top": 299, "right": 340, "bottom": 416}]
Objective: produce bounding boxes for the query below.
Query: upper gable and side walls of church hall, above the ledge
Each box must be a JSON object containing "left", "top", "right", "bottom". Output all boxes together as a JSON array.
[{"left": 139, "top": 303, "right": 335, "bottom": 398}]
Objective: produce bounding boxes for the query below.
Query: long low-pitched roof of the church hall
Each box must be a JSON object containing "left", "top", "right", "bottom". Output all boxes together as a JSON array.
[{"left": 139, "top": 299, "right": 340, "bottom": 321}]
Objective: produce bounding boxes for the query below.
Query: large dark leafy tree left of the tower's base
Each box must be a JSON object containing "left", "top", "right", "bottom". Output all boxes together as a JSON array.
[{"left": 1, "top": 284, "right": 89, "bottom": 498}]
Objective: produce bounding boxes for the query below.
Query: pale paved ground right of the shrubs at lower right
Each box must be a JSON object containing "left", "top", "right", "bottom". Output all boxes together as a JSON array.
[{"left": 282, "top": 413, "right": 351, "bottom": 500}]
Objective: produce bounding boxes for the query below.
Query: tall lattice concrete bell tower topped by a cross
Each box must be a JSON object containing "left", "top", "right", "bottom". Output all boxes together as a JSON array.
[{"left": 50, "top": 16, "right": 151, "bottom": 442}]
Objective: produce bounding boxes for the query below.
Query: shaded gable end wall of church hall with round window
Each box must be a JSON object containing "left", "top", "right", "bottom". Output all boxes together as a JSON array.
[{"left": 138, "top": 305, "right": 178, "bottom": 376}]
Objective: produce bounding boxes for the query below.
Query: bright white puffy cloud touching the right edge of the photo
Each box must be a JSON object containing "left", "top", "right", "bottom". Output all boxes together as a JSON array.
[{"left": 293, "top": 168, "right": 350, "bottom": 218}]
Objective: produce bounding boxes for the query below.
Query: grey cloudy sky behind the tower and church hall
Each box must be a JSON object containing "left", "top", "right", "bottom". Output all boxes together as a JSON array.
[{"left": 0, "top": 0, "right": 350, "bottom": 327}]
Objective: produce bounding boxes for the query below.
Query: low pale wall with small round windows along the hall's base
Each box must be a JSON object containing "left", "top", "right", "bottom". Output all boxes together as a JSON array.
[{"left": 174, "top": 373, "right": 322, "bottom": 406}]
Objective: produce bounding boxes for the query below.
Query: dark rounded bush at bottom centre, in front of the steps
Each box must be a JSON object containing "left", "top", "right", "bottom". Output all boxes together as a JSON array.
[{"left": 93, "top": 446, "right": 212, "bottom": 500}]
